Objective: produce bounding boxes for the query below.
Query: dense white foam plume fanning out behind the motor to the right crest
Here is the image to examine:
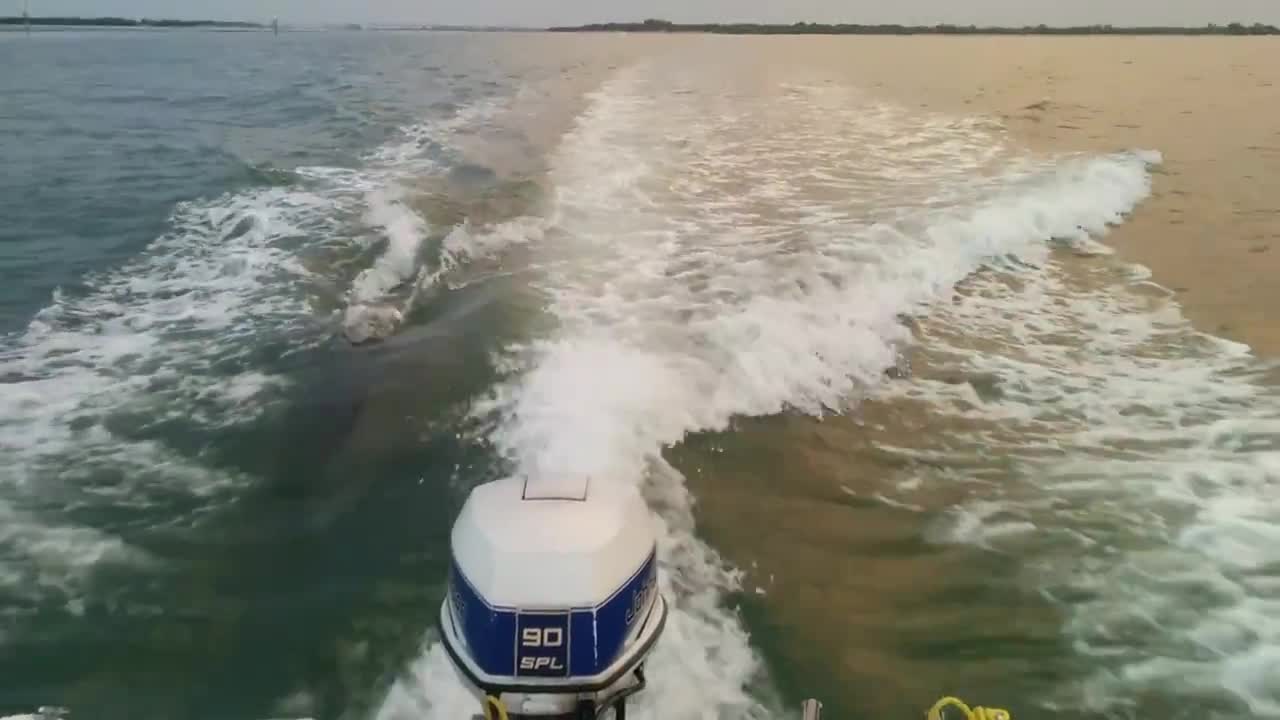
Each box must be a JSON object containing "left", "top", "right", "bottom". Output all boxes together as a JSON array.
[{"left": 383, "top": 67, "right": 1149, "bottom": 717}]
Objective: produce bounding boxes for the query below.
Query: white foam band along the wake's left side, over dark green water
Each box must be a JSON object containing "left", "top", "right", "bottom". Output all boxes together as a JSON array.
[{"left": 0, "top": 95, "right": 509, "bottom": 607}]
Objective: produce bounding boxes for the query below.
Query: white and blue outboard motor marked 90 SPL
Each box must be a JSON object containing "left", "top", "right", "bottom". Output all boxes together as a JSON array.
[{"left": 440, "top": 478, "right": 667, "bottom": 720}]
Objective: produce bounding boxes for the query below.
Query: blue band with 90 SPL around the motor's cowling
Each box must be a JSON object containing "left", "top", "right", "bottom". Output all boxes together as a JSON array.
[{"left": 449, "top": 553, "right": 658, "bottom": 678}]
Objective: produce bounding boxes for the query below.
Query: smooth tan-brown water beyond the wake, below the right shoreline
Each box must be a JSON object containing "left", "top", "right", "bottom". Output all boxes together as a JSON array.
[{"left": 788, "top": 37, "right": 1280, "bottom": 356}]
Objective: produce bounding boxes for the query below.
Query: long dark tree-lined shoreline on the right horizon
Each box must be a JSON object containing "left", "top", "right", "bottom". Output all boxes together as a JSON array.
[{"left": 548, "top": 20, "right": 1280, "bottom": 36}]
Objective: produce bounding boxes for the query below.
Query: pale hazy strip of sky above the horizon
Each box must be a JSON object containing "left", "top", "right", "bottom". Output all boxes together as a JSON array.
[{"left": 15, "top": 0, "right": 1280, "bottom": 26}]
